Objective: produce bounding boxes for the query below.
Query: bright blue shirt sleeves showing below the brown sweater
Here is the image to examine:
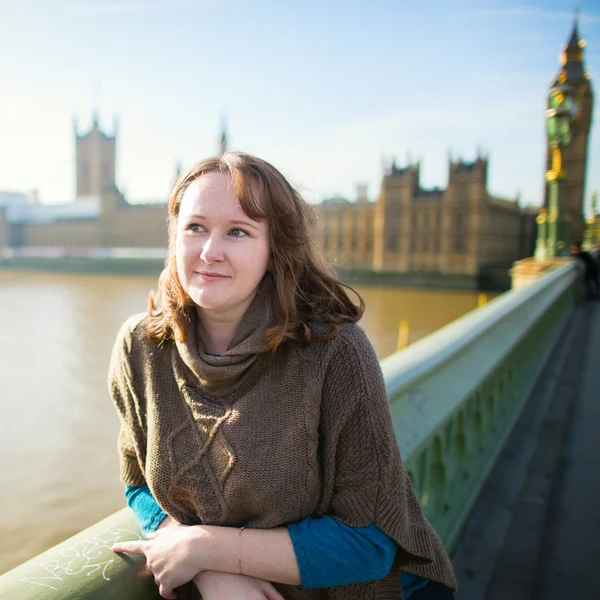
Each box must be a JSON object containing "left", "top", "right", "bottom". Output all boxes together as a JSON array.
[{"left": 125, "top": 485, "right": 429, "bottom": 600}]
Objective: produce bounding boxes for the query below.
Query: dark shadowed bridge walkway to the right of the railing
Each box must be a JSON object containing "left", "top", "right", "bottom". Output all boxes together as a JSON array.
[{"left": 454, "top": 304, "right": 600, "bottom": 600}]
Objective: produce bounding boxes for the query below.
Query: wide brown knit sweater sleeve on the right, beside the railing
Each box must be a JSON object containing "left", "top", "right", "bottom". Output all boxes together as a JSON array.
[{"left": 319, "top": 325, "right": 456, "bottom": 588}]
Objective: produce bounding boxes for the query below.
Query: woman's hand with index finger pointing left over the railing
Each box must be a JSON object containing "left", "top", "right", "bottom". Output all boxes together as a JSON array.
[{"left": 111, "top": 523, "right": 201, "bottom": 600}]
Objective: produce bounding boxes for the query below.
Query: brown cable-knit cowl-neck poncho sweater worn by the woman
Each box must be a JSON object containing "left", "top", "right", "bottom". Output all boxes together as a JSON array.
[{"left": 109, "top": 286, "right": 456, "bottom": 600}]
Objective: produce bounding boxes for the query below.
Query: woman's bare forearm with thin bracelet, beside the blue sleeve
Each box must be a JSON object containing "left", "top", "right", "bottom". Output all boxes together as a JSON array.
[{"left": 196, "top": 526, "right": 300, "bottom": 585}]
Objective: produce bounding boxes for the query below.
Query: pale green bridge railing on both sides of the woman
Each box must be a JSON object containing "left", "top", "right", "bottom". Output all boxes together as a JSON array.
[{"left": 0, "top": 264, "right": 577, "bottom": 600}]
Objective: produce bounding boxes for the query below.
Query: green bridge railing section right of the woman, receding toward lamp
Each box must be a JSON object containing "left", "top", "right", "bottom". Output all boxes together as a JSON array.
[{"left": 381, "top": 263, "right": 578, "bottom": 548}]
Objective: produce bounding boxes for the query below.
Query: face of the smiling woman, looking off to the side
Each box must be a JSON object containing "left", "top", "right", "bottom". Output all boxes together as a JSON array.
[{"left": 175, "top": 172, "right": 269, "bottom": 313}]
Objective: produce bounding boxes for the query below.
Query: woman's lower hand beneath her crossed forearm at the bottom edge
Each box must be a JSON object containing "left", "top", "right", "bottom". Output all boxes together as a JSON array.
[{"left": 194, "top": 571, "right": 284, "bottom": 600}]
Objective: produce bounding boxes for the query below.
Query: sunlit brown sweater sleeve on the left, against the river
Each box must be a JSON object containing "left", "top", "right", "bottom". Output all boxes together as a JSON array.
[{"left": 108, "top": 318, "right": 146, "bottom": 486}]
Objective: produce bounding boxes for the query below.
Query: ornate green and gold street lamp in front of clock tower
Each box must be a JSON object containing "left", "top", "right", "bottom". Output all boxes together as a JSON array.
[{"left": 535, "top": 82, "right": 577, "bottom": 260}]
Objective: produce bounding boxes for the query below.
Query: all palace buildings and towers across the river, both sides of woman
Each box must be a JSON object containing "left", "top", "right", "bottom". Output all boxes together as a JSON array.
[{"left": 0, "top": 20, "right": 593, "bottom": 286}]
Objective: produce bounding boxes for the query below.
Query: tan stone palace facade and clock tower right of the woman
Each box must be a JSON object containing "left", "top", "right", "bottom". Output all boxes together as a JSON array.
[{"left": 317, "top": 21, "right": 593, "bottom": 275}]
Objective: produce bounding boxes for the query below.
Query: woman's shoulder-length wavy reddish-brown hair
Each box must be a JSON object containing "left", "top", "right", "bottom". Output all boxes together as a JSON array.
[{"left": 148, "top": 152, "right": 365, "bottom": 352}]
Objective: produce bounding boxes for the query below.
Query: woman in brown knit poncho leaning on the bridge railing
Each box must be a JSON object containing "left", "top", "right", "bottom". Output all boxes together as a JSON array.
[{"left": 109, "top": 153, "right": 455, "bottom": 600}]
